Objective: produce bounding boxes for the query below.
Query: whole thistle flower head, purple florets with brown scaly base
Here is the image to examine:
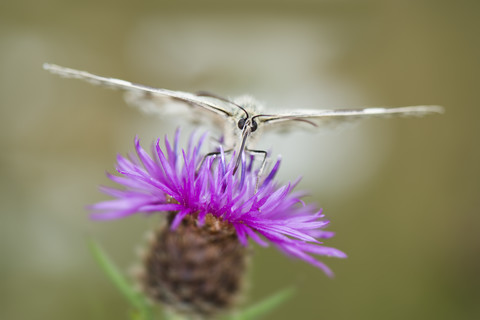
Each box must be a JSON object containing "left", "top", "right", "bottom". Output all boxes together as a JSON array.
[{"left": 90, "top": 131, "right": 346, "bottom": 315}]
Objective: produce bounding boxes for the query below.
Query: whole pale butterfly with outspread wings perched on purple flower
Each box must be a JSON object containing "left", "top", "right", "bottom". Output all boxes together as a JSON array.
[{"left": 43, "top": 63, "right": 443, "bottom": 171}]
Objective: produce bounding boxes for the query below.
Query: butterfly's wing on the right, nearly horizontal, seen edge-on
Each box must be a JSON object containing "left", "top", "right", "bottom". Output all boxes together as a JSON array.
[{"left": 258, "top": 106, "right": 444, "bottom": 128}]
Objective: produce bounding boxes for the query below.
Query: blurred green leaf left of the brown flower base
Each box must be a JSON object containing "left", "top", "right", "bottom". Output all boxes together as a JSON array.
[{"left": 88, "top": 240, "right": 153, "bottom": 320}]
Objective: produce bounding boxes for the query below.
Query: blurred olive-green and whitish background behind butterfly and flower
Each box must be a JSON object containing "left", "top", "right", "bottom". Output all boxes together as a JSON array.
[{"left": 0, "top": 0, "right": 480, "bottom": 320}]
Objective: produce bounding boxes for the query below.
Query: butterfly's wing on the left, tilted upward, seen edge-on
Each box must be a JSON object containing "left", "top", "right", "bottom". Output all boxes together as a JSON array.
[{"left": 43, "top": 63, "right": 233, "bottom": 117}]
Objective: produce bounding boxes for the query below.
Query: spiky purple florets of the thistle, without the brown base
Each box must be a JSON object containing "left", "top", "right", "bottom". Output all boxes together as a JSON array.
[{"left": 90, "top": 131, "right": 346, "bottom": 276}]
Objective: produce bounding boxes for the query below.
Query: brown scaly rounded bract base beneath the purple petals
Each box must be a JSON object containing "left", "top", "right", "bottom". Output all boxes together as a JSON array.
[{"left": 141, "top": 212, "right": 248, "bottom": 317}]
